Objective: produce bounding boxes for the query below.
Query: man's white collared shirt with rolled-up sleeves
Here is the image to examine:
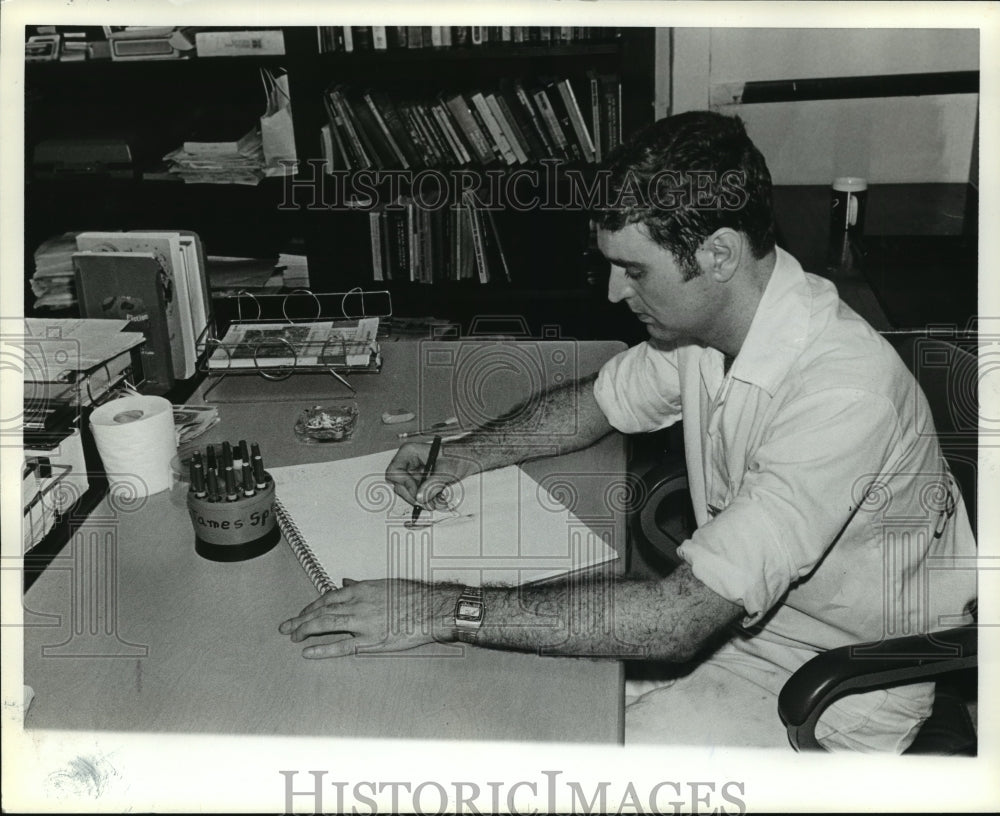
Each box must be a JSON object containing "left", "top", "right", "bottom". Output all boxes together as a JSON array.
[{"left": 594, "top": 249, "right": 975, "bottom": 752}]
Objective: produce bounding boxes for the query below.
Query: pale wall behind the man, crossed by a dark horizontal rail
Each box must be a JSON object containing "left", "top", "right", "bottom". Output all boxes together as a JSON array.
[{"left": 657, "top": 28, "right": 979, "bottom": 184}]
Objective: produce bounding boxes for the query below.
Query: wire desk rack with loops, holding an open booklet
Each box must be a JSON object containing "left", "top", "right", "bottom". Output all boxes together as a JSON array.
[{"left": 198, "top": 289, "right": 392, "bottom": 396}]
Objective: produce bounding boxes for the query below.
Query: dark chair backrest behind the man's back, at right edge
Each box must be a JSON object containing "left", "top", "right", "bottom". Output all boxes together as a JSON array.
[{"left": 886, "top": 334, "right": 979, "bottom": 530}]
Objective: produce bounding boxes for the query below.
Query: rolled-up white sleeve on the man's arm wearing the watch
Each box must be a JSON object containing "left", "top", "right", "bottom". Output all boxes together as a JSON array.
[{"left": 678, "top": 388, "right": 900, "bottom": 626}]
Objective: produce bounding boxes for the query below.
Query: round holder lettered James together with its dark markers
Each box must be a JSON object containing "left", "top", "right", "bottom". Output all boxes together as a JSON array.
[{"left": 187, "top": 440, "right": 281, "bottom": 561}]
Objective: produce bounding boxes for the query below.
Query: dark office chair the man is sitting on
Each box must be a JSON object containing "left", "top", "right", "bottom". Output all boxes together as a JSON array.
[{"left": 629, "top": 335, "right": 978, "bottom": 756}]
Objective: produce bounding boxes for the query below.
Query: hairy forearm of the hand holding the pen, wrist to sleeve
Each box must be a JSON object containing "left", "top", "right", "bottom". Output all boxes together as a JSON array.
[{"left": 448, "top": 374, "right": 611, "bottom": 470}]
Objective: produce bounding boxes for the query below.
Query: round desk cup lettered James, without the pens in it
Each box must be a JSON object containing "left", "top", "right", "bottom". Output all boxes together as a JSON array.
[{"left": 187, "top": 476, "right": 281, "bottom": 561}]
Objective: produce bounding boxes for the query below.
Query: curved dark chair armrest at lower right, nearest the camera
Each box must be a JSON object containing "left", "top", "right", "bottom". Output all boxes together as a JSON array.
[{"left": 778, "top": 625, "right": 978, "bottom": 750}]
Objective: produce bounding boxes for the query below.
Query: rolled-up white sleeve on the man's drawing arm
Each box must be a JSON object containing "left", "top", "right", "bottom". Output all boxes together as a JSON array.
[{"left": 594, "top": 343, "right": 681, "bottom": 433}]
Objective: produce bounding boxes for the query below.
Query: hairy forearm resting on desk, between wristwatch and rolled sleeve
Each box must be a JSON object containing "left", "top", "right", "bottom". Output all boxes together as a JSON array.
[{"left": 442, "top": 565, "right": 742, "bottom": 662}]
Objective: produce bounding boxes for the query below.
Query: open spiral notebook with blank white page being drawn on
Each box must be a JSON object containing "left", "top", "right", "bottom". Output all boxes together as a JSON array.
[{"left": 268, "top": 451, "right": 618, "bottom": 592}]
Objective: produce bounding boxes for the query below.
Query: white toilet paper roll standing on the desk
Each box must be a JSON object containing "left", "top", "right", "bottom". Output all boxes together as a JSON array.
[{"left": 90, "top": 396, "right": 177, "bottom": 496}]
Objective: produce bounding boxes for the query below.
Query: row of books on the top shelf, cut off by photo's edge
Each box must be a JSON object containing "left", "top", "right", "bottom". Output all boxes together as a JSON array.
[{"left": 316, "top": 26, "right": 620, "bottom": 54}]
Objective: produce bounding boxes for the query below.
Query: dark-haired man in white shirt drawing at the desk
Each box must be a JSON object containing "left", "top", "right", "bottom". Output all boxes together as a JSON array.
[{"left": 281, "top": 112, "right": 975, "bottom": 752}]
